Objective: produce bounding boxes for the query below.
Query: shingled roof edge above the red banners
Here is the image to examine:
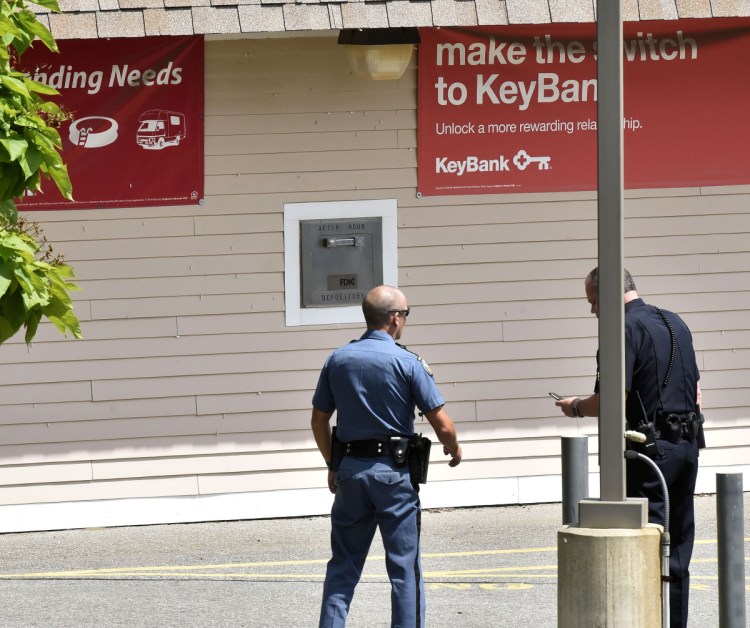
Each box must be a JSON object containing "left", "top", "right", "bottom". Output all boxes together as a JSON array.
[{"left": 33, "top": 0, "right": 750, "bottom": 39}]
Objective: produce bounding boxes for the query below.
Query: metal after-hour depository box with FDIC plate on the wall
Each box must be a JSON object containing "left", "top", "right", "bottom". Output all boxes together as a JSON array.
[{"left": 300, "top": 218, "right": 383, "bottom": 307}]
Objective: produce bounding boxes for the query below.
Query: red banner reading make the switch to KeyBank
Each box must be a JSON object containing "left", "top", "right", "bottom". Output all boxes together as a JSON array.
[{"left": 417, "top": 19, "right": 750, "bottom": 195}]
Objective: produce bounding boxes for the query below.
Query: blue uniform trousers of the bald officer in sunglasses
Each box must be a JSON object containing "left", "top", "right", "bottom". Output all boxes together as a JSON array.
[{"left": 320, "top": 456, "right": 425, "bottom": 628}]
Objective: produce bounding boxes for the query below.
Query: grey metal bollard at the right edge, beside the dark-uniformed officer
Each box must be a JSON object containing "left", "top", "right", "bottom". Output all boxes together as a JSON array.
[{"left": 716, "top": 473, "right": 746, "bottom": 628}]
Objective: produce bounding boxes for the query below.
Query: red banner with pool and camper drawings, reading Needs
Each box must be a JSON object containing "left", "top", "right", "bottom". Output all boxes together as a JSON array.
[{"left": 19, "top": 36, "right": 204, "bottom": 210}]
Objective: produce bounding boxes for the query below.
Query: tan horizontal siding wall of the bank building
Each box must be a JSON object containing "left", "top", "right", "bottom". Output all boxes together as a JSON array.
[{"left": 0, "top": 37, "right": 750, "bottom": 528}]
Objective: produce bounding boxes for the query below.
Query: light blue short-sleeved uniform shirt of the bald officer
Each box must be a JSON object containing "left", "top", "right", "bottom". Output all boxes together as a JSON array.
[{"left": 312, "top": 331, "right": 445, "bottom": 442}]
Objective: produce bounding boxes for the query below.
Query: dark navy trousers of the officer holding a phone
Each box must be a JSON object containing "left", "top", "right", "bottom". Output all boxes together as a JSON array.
[{"left": 627, "top": 440, "right": 698, "bottom": 628}]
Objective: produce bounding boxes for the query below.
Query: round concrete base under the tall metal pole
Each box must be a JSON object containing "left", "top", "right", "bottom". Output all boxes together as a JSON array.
[{"left": 557, "top": 524, "right": 662, "bottom": 628}]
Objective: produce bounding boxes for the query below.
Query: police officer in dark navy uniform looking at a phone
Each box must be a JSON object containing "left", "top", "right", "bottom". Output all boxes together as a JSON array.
[{"left": 555, "top": 268, "right": 704, "bottom": 628}]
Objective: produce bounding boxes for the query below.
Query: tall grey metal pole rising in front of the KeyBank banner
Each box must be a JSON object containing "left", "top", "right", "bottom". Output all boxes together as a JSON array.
[{"left": 596, "top": 0, "right": 625, "bottom": 502}]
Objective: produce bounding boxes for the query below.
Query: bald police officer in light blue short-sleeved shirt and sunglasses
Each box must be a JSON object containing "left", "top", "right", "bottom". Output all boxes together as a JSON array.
[{"left": 311, "top": 286, "right": 461, "bottom": 628}]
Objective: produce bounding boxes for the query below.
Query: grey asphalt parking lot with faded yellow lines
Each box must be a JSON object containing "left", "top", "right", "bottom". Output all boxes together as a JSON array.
[{"left": 0, "top": 493, "right": 750, "bottom": 628}]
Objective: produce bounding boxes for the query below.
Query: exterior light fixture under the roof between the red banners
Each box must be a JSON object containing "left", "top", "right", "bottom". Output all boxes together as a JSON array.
[{"left": 338, "top": 28, "right": 419, "bottom": 80}]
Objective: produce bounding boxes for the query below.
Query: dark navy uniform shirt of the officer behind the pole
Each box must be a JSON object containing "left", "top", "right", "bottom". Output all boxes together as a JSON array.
[{"left": 595, "top": 299, "right": 700, "bottom": 428}]
